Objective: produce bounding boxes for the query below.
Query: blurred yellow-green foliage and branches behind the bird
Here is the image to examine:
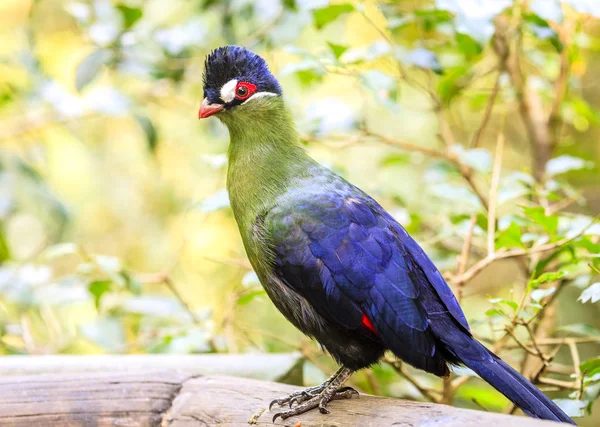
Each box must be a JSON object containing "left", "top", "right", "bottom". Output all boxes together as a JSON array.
[{"left": 0, "top": 0, "right": 600, "bottom": 425}]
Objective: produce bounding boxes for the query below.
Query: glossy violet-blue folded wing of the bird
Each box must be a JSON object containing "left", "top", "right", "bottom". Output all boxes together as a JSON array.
[{"left": 264, "top": 184, "right": 468, "bottom": 372}]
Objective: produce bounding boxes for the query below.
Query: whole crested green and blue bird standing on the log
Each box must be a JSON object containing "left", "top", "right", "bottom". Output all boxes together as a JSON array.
[{"left": 198, "top": 46, "right": 575, "bottom": 424}]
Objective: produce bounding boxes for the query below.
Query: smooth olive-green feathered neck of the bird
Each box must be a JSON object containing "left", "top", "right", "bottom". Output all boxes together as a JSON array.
[{"left": 219, "top": 96, "right": 315, "bottom": 235}]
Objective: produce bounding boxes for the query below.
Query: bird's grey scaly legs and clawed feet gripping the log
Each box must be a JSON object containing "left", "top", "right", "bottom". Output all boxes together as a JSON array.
[{"left": 269, "top": 366, "right": 358, "bottom": 422}]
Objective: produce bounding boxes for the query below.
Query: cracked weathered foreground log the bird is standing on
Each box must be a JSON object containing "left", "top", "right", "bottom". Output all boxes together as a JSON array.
[{"left": 0, "top": 370, "right": 558, "bottom": 427}]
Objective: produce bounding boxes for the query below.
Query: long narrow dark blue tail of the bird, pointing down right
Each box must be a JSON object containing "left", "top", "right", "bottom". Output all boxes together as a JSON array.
[{"left": 452, "top": 337, "right": 576, "bottom": 425}]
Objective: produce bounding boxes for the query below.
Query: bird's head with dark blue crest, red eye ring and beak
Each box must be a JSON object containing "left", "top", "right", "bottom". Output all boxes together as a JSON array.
[{"left": 198, "top": 46, "right": 281, "bottom": 119}]
